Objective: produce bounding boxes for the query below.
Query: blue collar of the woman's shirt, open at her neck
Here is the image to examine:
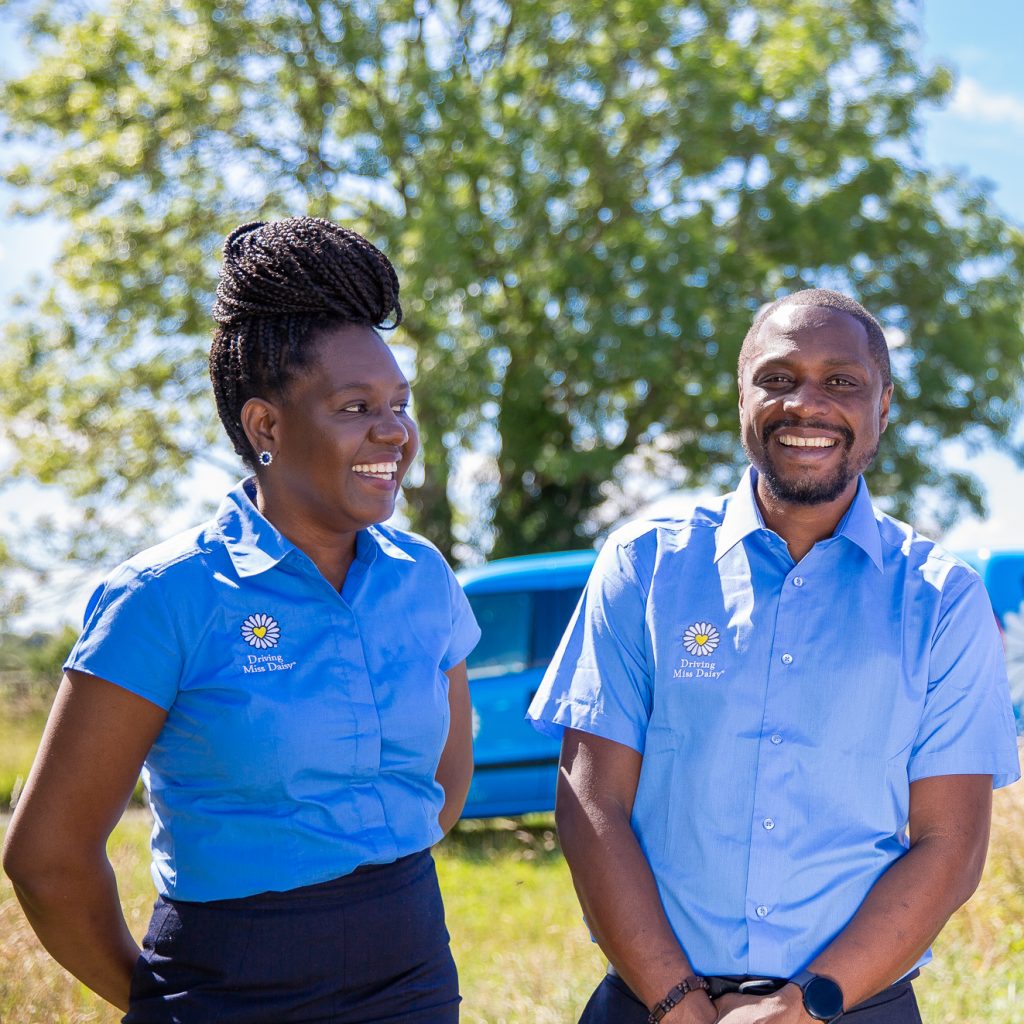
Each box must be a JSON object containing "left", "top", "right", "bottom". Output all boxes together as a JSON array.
[{"left": 217, "top": 476, "right": 416, "bottom": 578}]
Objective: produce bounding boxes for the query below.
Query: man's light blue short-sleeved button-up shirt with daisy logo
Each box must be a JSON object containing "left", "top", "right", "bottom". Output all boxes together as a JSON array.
[{"left": 529, "top": 470, "right": 1020, "bottom": 978}]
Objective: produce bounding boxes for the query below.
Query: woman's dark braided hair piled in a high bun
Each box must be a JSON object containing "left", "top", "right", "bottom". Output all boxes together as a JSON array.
[{"left": 210, "top": 217, "right": 401, "bottom": 466}]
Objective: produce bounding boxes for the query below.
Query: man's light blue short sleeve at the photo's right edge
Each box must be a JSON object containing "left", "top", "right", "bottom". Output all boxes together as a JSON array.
[{"left": 908, "top": 572, "right": 1020, "bottom": 788}]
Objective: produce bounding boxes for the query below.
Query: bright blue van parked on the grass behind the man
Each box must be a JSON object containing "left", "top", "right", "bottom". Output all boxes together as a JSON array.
[{"left": 458, "top": 549, "right": 1024, "bottom": 818}]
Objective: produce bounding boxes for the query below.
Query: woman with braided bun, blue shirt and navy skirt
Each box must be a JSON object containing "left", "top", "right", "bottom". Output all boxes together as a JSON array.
[{"left": 4, "top": 218, "right": 479, "bottom": 1024}]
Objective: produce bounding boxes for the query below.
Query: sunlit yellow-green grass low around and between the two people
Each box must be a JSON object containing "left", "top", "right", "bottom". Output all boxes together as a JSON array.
[{"left": 0, "top": 785, "right": 1024, "bottom": 1024}]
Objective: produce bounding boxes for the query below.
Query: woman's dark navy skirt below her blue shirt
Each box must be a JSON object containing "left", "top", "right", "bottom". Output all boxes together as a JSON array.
[{"left": 124, "top": 850, "right": 460, "bottom": 1024}]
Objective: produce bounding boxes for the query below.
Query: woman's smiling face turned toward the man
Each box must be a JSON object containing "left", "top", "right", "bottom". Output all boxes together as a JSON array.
[{"left": 265, "top": 326, "right": 419, "bottom": 534}]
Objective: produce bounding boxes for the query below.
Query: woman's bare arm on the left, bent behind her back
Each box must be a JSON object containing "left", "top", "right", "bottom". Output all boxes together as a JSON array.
[{"left": 3, "top": 672, "right": 167, "bottom": 1010}]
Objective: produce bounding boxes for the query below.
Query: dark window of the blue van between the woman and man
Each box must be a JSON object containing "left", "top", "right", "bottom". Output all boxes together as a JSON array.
[{"left": 466, "top": 587, "right": 581, "bottom": 679}]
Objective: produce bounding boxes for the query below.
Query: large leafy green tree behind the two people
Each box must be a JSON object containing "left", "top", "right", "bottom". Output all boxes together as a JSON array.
[{"left": 0, "top": 0, "right": 1024, "bottom": 577}]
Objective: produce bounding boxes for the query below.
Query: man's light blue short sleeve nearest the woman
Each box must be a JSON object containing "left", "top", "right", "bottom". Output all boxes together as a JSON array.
[{"left": 527, "top": 538, "right": 651, "bottom": 754}]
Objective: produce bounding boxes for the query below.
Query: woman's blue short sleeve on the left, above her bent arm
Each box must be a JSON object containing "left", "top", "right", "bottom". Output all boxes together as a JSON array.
[{"left": 65, "top": 565, "right": 182, "bottom": 711}]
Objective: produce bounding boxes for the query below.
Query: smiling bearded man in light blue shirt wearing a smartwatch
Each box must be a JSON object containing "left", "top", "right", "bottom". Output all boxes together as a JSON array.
[{"left": 529, "top": 290, "right": 1020, "bottom": 1024}]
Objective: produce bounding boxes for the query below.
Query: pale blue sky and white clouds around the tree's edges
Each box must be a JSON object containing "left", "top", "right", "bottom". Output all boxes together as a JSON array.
[{"left": 0, "top": 0, "right": 1024, "bottom": 620}]
